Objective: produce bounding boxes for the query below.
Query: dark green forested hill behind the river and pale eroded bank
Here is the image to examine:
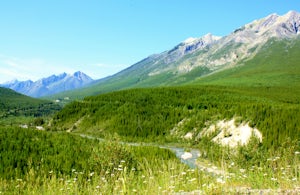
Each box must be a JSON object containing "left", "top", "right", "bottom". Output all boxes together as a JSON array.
[{"left": 53, "top": 86, "right": 300, "bottom": 147}]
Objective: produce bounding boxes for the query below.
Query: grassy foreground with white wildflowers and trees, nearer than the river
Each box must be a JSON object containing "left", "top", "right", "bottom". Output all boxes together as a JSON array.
[{"left": 0, "top": 126, "right": 300, "bottom": 194}]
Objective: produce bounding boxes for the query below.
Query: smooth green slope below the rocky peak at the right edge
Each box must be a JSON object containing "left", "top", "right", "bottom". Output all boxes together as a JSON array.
[{"left": 195, "top": 37, "right": 300, "bottom": 90}]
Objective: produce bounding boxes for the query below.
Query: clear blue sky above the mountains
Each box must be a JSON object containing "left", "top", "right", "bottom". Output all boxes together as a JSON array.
[{"left": 0, "top": 0, "right": 300, "bottom": 83}]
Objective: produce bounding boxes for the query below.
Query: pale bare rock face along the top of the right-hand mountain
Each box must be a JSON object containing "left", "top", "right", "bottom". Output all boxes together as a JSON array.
[{"left": 166, "top": 11, "right": 300, "bottom": 73}]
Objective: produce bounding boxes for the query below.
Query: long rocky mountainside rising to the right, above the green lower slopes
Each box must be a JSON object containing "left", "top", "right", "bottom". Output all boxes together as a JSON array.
[{"left": 50, "top": 11, "right": 300, "bottom": 98}]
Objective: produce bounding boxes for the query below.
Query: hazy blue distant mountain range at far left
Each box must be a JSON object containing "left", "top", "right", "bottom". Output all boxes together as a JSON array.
[{"left": 0, "top": 71, "right": 94, "bottom": 97}]
